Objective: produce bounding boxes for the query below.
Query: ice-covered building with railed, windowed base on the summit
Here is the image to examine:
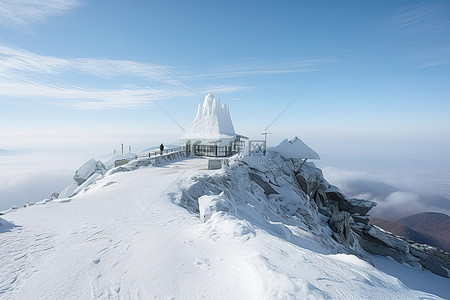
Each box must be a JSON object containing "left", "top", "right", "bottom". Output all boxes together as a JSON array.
[{"left": 179, "top": 94, "right": 248, "bottom": 157}]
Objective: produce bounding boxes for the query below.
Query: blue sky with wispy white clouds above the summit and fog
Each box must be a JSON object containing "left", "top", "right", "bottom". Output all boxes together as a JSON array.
[{"left": 0, "top": 0, "right": 450, "bottom": 210}]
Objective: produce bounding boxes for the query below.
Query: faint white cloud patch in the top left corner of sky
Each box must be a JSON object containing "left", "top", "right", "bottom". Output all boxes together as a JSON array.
[{"left": 0, "top": 0, "right": 80, "bottom": 28}]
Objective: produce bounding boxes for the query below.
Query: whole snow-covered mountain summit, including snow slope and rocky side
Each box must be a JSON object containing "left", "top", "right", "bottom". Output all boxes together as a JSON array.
[{"left": 0, "top": 152, "right": 450, "bottom": 299}]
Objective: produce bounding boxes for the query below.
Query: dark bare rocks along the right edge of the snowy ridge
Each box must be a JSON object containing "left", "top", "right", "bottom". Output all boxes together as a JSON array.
[{"left": 294, "top": 162, "right": 450, "bottom": 278}]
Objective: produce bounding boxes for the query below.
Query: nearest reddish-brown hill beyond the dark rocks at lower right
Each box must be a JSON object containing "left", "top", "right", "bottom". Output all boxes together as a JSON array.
[{"left": 370, "top": 212, "right": 450, "bottom": 252}]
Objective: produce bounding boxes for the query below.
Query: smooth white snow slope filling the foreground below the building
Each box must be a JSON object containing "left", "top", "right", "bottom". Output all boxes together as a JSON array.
[{"left": 0, "top": 158, "right": 450, "bottom": 299}]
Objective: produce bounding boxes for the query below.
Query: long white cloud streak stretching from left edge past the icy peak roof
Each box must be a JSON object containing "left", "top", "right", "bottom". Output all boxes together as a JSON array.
[{"left": 0, "top": 45, "right": 335, "bottom": 109}]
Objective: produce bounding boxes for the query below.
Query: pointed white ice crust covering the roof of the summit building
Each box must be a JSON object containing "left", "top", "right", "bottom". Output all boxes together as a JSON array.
[{"left": 179, "top": 94, "right": 236, "bottom": 144}]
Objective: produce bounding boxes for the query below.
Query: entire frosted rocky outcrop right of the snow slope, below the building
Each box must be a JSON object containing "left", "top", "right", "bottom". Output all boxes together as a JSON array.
[{"left": 174, "top": 154, "right": 450, "bottom": 277}]
